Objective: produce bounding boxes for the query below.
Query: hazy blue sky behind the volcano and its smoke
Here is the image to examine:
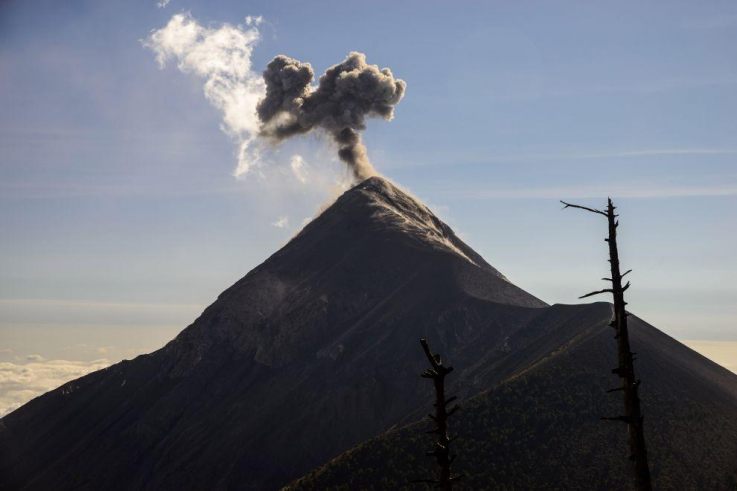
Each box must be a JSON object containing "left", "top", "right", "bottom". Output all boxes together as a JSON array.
[{"left": 0, "top": 0, "right": 737, "bottom": 412}]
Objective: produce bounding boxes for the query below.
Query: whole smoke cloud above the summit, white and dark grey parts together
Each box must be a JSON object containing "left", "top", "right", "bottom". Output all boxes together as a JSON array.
[{"left": 142, "top": 13, "right": 406, "bottom": 183}]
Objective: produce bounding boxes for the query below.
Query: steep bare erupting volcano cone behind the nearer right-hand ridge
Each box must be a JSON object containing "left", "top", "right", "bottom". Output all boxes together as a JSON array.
[{"left": 0, "top": 178, "right": 735, "bottom": 490}]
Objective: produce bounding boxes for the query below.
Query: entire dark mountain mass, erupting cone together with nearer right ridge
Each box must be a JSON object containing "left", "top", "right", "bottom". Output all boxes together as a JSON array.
[{"left": 0, "top": 177, "right": 737, "bottom": 490}]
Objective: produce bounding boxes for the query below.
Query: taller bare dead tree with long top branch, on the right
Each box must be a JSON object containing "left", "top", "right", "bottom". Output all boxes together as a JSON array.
[{"left": 561, "top": 199, "right": 652, "bottom": 491}]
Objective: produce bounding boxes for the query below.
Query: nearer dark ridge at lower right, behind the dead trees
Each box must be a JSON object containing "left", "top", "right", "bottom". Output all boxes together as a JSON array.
[{"left": 286, "top": 317, "right": 737, "bottom": 491}]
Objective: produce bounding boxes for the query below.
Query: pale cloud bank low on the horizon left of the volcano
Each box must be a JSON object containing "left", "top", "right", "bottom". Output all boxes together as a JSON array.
[{"left": 0, "top": 360, "right": 110, "bottom": 417}]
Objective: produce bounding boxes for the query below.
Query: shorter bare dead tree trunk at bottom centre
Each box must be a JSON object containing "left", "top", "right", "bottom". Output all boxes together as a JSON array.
[{"left": 413, "top": 339, "right": 463, "bottom": 491}]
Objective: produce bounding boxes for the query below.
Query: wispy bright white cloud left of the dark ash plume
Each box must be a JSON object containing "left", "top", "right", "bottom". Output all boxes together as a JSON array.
[{"left": 143, "top": 13, "right": 265, "bottom": 177}]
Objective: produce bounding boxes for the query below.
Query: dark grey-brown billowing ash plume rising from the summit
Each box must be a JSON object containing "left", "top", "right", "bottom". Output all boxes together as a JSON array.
[{"left": 256, "top": 52, "right": 407, "bottom": 180}]
